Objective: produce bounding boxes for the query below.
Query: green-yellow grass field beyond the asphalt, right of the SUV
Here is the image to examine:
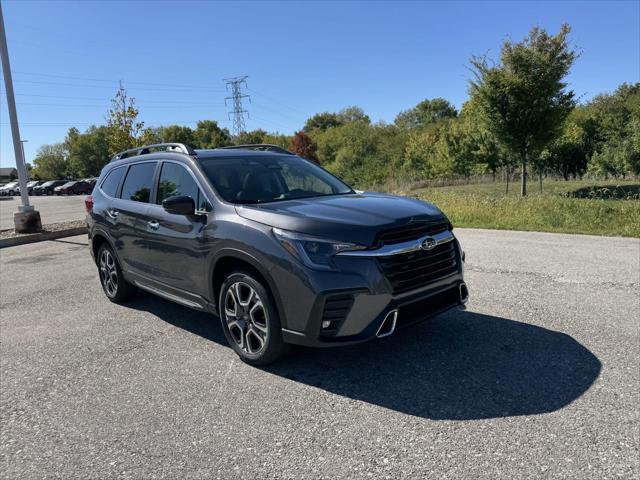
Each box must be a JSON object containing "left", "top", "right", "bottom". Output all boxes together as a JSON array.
[{"left": 405, "top": 180, "right": 640, "bottom": 237}]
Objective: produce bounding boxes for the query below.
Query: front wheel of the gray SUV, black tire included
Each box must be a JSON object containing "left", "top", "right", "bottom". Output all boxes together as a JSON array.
[{"left": 218, "top": 271, "right": 289, "bottom": 366}]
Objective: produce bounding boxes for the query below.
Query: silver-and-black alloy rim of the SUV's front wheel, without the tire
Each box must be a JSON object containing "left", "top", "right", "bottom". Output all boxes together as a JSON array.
[{"left": 224, "top": 282, "right": 269, "bottom": 355}]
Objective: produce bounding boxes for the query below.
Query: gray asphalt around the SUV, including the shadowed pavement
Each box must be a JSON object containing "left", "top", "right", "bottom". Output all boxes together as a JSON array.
[{"left": 0, "top": 229, "right": 640, "bottom": 479}]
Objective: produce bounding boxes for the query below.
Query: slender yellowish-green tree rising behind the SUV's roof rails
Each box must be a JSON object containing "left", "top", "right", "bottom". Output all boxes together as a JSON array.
[{"left": 107, "top": 86, "right": 144, "bottom": 155}]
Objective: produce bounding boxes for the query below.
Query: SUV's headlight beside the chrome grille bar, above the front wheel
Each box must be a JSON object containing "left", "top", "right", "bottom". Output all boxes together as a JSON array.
[{"left": 272, "top": 228, "right": 365, "bottom": 270}]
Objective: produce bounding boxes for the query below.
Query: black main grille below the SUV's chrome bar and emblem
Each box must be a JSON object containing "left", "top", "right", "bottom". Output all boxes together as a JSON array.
[{"left": 378, "top": 242, "right": 458, "bottom": 293}]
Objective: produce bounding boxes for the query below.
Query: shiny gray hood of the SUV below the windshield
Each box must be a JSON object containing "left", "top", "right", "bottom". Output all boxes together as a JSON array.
[{"left": 236, "top": 192, "right": 446, "bottom": 246}]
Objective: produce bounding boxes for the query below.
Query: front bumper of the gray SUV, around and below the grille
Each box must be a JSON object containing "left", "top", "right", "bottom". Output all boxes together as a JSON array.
[{"left": 272, "top": 234, "right": 468, "bottom": 347}]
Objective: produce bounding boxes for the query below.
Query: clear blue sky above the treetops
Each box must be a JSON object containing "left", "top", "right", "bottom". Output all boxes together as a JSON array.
[{"left": 0, "top": 0, "right": 640, "bottom": 166}]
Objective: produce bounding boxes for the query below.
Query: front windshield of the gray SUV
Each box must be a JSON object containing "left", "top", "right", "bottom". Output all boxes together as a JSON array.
[{"left": 200, "top": 156, "right": 354, "bottom": 203}]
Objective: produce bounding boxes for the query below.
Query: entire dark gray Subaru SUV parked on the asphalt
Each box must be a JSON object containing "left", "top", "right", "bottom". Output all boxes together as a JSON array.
[{"left": 85, "top": 144, "right": 468, "bottom": 365}]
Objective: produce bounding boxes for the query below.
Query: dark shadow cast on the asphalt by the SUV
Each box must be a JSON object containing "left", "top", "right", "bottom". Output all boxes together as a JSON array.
[{"left": 127, "top": 294, "right": 601, "bottom": 420}]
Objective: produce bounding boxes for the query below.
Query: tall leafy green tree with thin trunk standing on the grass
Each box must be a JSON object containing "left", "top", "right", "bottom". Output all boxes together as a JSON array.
[{"left": 470, "top": 25, "right": 578, "bottom": 196}]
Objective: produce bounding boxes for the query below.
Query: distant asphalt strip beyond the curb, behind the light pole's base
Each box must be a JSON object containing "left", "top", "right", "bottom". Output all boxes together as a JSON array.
[{"left": 0, "top": 195, "right": 85, "bottom": 229}]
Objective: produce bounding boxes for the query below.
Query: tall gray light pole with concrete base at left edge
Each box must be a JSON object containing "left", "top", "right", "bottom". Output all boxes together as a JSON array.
[{"left": 0, "top": 4, "right": 42, "bottom": 233}]
